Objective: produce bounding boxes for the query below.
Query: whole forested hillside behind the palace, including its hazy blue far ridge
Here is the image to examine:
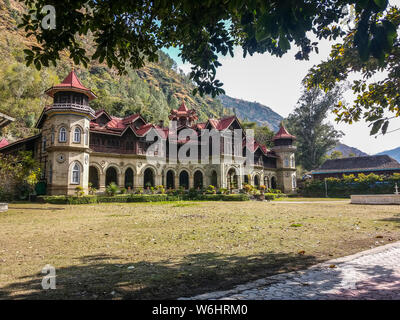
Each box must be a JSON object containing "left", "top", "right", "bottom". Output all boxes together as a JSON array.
[{"left": 0, "top": 0, "right": 282, "bottom": 141}]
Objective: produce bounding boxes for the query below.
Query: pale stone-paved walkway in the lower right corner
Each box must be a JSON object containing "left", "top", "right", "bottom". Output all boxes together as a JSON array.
[{"left": 183, "top": 242, "right": 400, "bottom": 300}]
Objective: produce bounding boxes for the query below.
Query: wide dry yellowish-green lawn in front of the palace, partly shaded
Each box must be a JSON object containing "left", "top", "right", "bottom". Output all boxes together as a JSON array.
[{"left": 0, "top": 200, "right": 400, "bottom": 299}]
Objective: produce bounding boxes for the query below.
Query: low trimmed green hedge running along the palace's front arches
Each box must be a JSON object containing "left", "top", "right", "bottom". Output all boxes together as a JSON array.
[{"left": 38, "top": 194, "right": 249, "bottom": 204}]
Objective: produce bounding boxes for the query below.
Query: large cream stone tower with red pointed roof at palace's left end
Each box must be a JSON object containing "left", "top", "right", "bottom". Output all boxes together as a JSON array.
[{"left": 36, "top": 70, "right": 96, "bottom": 195}]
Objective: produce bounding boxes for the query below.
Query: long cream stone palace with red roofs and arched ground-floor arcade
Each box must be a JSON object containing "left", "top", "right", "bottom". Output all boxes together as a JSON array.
[{"left": 0, "top": 70, "right": 296, "bottom": 195}]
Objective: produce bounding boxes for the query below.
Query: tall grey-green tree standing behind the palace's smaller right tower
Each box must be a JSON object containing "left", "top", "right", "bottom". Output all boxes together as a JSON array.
[{"left": 287, "top": 87, "right": 342, "bottom": 170}]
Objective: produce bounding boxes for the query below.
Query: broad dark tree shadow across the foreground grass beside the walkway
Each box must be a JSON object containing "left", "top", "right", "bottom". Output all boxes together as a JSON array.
[{"left": 0, "top": 252, "right": 317, "bottom": 299}]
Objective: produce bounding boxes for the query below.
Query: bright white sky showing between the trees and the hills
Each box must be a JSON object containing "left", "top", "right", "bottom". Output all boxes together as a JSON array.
[{"left": 165, "top": 13, "right": 400, "bottom": 154}]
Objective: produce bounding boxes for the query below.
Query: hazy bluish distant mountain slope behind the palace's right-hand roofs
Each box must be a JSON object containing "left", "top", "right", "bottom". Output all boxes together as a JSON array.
[{"left": 218, "top": 95, "right": 283, "bottom": 131}]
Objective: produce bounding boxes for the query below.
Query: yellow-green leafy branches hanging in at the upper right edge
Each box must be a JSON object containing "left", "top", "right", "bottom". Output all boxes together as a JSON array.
[{"left": 307, "top": 1, "right": 400, "bottom": 135}]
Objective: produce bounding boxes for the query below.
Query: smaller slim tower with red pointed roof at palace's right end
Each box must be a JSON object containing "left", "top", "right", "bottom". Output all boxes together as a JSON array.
[{"left": 272, "top": 122, "right": 296, "bottom": 193}]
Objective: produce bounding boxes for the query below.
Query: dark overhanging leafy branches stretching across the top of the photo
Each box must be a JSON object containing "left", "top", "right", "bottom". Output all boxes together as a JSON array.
[{"left": 20, "top": 0, "right": 396, "bottom": 96}]
